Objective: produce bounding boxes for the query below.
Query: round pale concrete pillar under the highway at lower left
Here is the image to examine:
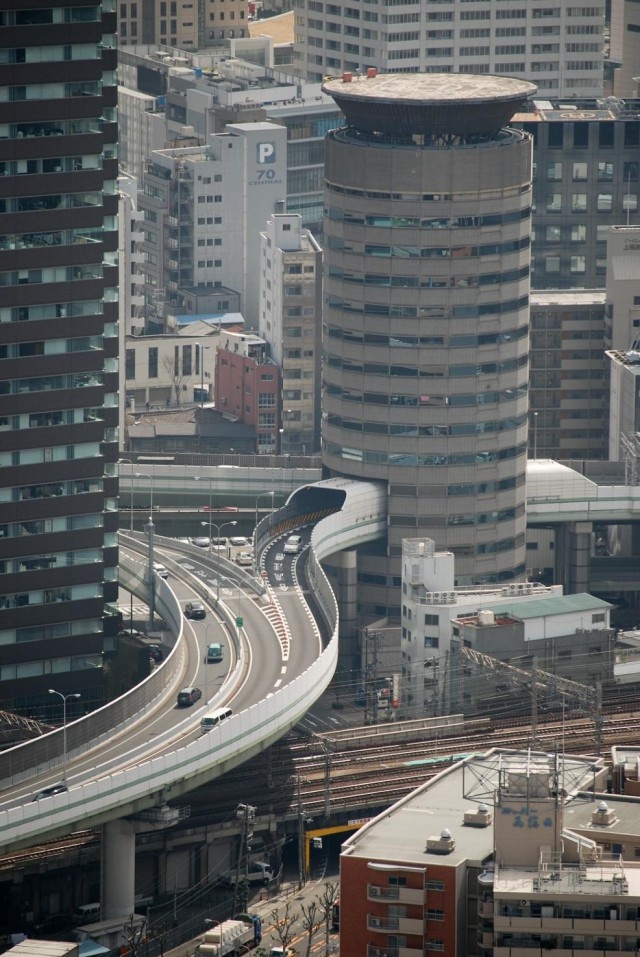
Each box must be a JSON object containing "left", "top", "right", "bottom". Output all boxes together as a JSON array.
[{"left": 101, "top": 819, "right": 136, "bottom": 920}]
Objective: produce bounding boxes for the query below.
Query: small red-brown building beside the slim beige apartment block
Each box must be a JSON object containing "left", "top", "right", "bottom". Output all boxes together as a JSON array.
[{"left": 215, "top": 333, "right": 281, "bottom": 453}]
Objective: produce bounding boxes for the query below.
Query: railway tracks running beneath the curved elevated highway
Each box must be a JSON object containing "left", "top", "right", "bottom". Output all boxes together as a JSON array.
[{"left": 5, "top": 699, "right": 640, "bottom": 871}]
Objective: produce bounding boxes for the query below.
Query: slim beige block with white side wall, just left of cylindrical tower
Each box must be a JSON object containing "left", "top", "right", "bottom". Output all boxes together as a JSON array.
[{"left": 258, "top": 213, "right": 322, "bottom": 455}]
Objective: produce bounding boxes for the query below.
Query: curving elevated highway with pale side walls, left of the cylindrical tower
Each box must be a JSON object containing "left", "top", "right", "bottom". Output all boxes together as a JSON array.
[{"left": 0, "top": 480, "right": 384, "bottom": 917}]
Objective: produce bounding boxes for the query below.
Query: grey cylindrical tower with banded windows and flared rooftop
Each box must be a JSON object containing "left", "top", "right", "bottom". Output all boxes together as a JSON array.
[{"left": 322, "top": 70, "right": 536, "bottom": 592}]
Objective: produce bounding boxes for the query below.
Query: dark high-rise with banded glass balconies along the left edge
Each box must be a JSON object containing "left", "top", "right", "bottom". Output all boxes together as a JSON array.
[{"left": 0, "top": 0, "right": 118, "bottom": 713}]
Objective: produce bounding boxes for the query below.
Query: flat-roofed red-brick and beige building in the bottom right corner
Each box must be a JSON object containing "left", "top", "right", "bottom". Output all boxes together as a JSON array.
[{"left": 340, "top": 749, "right": 640, "bottom": 957}]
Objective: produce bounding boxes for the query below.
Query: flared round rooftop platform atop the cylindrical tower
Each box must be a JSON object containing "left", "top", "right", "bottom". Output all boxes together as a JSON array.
[{"left": 322, "top": 69, "right": 537, "bottom": 137}]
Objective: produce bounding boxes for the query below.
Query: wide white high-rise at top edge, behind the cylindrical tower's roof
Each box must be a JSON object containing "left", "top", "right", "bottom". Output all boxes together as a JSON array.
[{"left": 294, "top": 0, "right": 604, "bottom": 97}]
